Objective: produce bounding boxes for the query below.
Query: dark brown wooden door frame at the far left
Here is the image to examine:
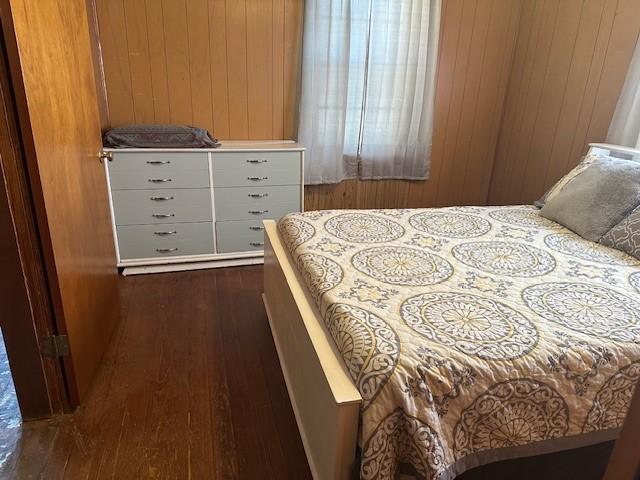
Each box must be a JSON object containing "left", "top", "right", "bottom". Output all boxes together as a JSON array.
[{"left": 0, "top": 5, "right": 70, "bottom": 419}]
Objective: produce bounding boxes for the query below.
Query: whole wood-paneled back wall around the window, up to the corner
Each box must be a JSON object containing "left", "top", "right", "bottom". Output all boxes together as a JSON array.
[{"left": 97, "top": 0, "right": 522, "bottom": 209}]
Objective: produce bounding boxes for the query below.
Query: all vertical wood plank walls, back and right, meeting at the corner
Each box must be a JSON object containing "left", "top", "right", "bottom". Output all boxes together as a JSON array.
[{"left": 96, "top": 0, "right": 640, "bottom": 210}]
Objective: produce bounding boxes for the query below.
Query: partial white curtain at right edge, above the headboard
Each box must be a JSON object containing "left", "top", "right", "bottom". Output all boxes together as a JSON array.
[{"left": 607, "top": 40, "right": 640, "bottom": 148}]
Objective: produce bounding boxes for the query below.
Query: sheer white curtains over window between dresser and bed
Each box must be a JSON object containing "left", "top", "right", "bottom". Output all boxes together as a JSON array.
[{"left": 299, "top": 0, "right": 440, "bottom": 184}]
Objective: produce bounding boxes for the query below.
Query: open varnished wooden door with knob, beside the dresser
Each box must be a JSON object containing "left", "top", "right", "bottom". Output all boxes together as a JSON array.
[{"left": 2, "top": 0, "right": 118, "bottom": 404}]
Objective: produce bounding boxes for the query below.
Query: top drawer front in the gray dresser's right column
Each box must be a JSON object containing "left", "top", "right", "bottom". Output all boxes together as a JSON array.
[{"left": 213, "top": 152, "right": 301, "bottom": 187}]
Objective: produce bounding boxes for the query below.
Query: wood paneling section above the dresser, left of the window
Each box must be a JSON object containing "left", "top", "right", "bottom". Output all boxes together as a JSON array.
[{"left": 96, "top": 0, "right": 302, "bottom": 139}]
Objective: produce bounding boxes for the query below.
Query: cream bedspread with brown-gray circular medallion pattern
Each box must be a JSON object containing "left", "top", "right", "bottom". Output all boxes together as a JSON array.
[{"left": 278, "top": 207, "right": 640, "bottom": 479}]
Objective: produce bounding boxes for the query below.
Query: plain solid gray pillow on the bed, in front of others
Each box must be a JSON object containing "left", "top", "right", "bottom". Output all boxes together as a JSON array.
[{"left": 540, "top": 157, "right": 640, "bottom": 242}]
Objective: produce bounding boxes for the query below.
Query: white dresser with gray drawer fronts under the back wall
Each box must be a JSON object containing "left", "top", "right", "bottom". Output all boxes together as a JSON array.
[{"left": 104, "top": 141, "right": 304, "bottom": 274}]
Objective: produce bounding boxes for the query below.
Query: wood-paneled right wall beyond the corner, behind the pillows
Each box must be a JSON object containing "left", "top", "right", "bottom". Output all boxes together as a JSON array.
[{"left": 489, "top": 0, "right": 640, "bottom": 204}]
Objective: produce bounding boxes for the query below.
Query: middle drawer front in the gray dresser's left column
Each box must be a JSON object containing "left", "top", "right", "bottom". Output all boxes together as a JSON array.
[{"left": 113, "top": 188, "right": 213, "bottom": 225}]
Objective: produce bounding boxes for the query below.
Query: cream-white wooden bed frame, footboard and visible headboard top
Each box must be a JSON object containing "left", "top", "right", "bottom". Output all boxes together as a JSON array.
[{"left": 263, "top": 143, "right": 640, "bottom": 480}]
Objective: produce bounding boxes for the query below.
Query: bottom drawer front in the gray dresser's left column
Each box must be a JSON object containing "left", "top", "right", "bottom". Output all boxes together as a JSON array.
[{"left": 117, "top": 222, "right": 213, "bottom": 260}]
